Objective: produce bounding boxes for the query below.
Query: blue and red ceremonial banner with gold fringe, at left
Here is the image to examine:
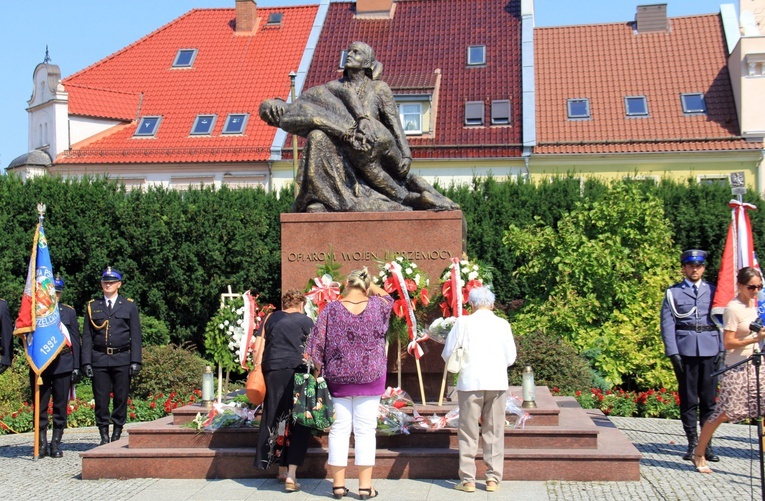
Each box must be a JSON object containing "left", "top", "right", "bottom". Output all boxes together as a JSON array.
[{"left": 13, "top": 217, "right": 70, "bottom": 375}]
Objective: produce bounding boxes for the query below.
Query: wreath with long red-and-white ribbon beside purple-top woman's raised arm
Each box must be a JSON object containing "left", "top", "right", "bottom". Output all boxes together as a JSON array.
[{"left": 374, "top": 256, "right": 430, "bottom": 359}]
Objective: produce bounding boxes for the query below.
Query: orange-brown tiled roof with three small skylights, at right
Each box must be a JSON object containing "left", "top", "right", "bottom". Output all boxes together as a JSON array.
[{"left": 534, "top": 15, "right": 762, "bottom": 154}]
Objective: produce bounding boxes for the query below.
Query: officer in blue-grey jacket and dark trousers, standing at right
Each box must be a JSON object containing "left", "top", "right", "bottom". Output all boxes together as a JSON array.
[{"left": 661, "top": 249, "right": 725, "bottom": 461}]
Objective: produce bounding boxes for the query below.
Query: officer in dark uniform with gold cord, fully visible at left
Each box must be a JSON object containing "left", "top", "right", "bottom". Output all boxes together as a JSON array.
[{"left": 82, "top": 267, "right": 141, "bottom": 444}]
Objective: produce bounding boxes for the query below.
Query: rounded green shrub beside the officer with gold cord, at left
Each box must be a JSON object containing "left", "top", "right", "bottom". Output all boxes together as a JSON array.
[{"left": 131, "top": 345, "right": 207, "bottom": 398}]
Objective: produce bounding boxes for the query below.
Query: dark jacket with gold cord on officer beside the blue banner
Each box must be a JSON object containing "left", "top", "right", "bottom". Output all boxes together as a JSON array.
[{"left": 82, "top": 296, "right": 141, "bottom": 367}]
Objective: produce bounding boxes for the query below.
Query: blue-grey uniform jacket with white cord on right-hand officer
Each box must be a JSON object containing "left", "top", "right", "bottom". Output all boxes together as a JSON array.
[{"left": 661, "top": 280, "right": 725, "bottom": 357}]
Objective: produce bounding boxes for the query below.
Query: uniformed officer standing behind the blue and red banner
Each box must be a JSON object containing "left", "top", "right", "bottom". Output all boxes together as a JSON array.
[{"left": 29, "top": 275, "right": 81, "bottom": 458}]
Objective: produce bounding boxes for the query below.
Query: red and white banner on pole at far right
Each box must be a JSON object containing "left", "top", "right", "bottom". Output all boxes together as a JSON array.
[{"left": 712, "top": 200, "right": 759, "bottom": 326}]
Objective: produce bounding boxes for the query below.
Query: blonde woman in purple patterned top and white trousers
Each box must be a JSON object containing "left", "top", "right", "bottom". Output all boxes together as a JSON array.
[{"left": 306, "top": 267, "right": 393, "bottom": 499}]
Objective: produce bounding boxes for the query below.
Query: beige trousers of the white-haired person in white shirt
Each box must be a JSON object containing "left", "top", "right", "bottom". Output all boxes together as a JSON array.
[{"left": 457, "top": 390, "right": 507, "bottom": 483}]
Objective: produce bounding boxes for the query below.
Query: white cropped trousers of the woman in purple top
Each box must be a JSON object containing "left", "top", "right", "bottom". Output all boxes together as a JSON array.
[{"left": 328, "top": 395, "right": 380, "bottom": 466}]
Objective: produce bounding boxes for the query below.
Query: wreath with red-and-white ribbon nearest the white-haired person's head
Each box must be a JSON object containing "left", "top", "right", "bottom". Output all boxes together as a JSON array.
[{"left": 439, "top": 257, "right": 491, "bottom": 318}]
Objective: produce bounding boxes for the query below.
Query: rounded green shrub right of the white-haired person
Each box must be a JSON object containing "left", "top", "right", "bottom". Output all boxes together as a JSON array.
[{"left": 508, "top": 331, "right": 592, "bottom": 395}]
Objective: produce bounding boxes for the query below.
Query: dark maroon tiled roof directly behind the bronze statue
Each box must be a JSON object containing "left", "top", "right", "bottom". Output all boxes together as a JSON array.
[{"left": 302, "top": 0, "right": 522, "bottom": 158}]
